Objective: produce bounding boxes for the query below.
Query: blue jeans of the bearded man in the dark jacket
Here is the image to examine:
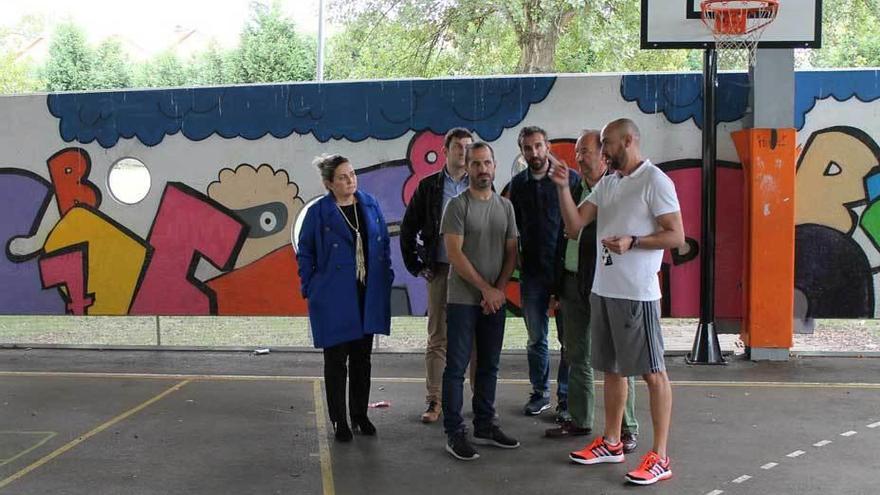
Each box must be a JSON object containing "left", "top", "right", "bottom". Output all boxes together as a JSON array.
[{"left": 520, "top": 277, "right": 568, "bottom": 401}]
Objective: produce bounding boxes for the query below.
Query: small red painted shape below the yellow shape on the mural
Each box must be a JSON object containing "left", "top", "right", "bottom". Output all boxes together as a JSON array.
[{"left": 40, "top": 250, "right": 95, "bottom": 316}]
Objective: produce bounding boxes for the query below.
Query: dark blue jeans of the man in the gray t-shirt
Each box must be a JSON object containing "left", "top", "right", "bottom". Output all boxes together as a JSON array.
[{"left": 443, "top": 304, "right": 505, "bottom": 435}]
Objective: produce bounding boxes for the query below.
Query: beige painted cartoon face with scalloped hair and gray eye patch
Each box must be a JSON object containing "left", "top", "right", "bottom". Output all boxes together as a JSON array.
[{"left": 208, "top": 164, "right": 305, "bottom": 268}]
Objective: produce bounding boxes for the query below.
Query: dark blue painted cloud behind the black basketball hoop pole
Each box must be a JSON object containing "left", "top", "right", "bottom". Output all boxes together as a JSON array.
[{"left": 620, "top": 73, "right": 749, "bottom": 127}]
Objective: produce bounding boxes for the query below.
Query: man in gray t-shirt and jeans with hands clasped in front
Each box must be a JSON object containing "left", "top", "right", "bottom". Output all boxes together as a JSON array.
[{"left": 440, "top": 142, "right": 519, "bottom": 461}]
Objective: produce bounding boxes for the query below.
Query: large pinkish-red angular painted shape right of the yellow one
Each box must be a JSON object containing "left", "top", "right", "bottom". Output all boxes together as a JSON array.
[{"left": 130, "top": 183, "right": 245, "bottom": 315}]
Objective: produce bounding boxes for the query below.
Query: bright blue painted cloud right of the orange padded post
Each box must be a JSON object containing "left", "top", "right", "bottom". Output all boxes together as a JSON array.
[{"left": 794, "top": 70, "right": 880, "bottom": 129}]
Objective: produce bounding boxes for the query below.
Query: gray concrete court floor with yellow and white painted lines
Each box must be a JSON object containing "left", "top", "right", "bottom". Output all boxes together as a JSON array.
[{"left": 0, "top": 350, "right": 880, "bottom": 495}]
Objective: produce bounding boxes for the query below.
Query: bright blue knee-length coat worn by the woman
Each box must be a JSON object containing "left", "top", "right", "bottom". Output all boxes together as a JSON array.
[{"left": 296, "top": 191, "right": 394, "bottom": 348}]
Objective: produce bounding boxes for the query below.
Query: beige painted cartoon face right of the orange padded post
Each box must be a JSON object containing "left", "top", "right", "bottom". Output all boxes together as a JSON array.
[{"left": 795, "top": 126, "right": 880, "bottom": 234}]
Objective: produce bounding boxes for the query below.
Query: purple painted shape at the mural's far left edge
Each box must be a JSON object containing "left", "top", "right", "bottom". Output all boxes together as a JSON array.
[{"left": 0, "top": 169, "right": 65, "bottom": 315}]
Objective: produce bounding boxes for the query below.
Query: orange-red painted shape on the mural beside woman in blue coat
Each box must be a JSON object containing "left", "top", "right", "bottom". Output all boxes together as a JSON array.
[{"left": 208, "top": 246, "right": 308, "bottom": 316}]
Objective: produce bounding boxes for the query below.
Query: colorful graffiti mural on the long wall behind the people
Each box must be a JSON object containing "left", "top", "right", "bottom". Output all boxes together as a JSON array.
[{"left": 0, "top": 70, "right": 880, "bottom": 319}]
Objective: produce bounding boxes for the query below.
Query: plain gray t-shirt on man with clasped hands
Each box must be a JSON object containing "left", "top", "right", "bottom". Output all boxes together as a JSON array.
[{"left": 440, "top": 191, "right": 518, "bottom": 306}]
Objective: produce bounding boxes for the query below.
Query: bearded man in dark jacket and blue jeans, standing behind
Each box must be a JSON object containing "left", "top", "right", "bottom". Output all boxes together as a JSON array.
[{"left": 510, "top": 126, "right": 580, "bottom": 421}]
